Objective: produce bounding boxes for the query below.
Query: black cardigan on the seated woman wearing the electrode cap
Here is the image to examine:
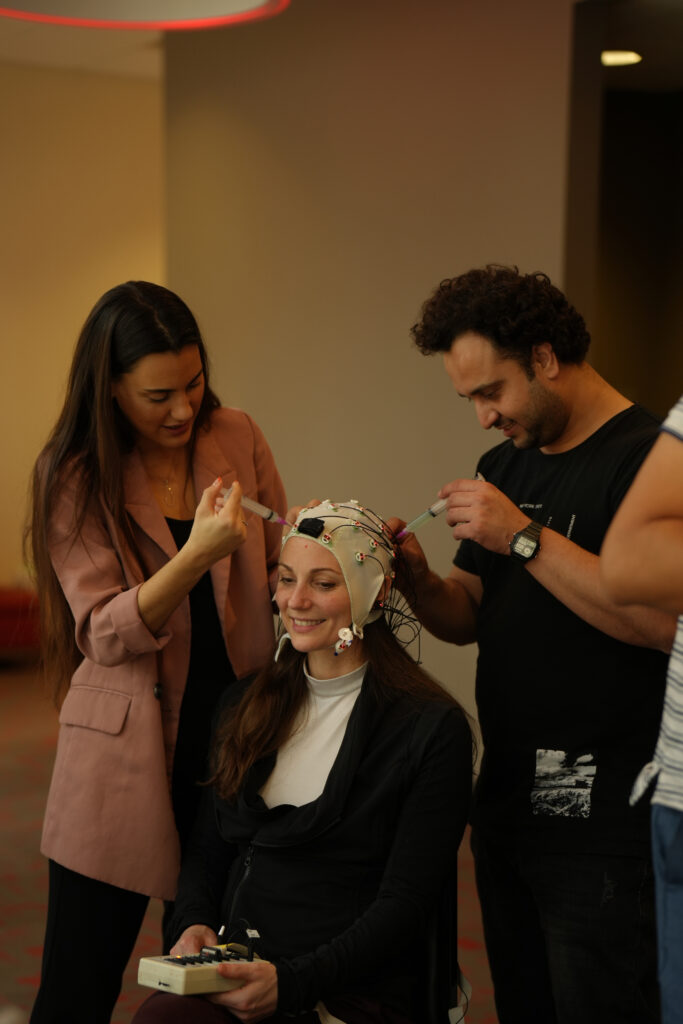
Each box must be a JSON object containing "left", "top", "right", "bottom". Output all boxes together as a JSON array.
[{"left": 174, "top": 670, "right": 472, "bottom": 1015}]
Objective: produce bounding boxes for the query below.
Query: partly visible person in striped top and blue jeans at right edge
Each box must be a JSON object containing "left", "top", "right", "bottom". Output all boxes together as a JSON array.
[{"left": 601, "top": 395, "right": 683, "bottom": 1024}]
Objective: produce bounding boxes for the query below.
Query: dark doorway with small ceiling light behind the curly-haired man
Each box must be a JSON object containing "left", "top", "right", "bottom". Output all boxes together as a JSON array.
[{"left": 565, "top": 0, "right": 683, "bottom": 415}]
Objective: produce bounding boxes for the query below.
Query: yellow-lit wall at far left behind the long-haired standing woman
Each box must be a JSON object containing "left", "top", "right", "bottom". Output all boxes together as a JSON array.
[{"left": 0, "top": 63, "right": 165, "bottom": 586}]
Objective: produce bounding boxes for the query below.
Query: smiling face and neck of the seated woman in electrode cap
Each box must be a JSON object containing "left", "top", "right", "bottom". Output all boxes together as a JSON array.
[{"left": 275, "top": 537, "right": 365, "bottom": 679}]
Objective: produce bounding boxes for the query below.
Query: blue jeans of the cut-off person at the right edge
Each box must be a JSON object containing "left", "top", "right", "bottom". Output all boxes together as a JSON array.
[{"left": 652, "top": 804, "right": 683, "bottom": 1024}]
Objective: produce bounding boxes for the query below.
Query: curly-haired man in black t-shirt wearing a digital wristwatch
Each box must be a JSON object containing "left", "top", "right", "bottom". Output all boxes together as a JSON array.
[{"left": 392, "top": 266, "right": 675, "bottom": 1024}]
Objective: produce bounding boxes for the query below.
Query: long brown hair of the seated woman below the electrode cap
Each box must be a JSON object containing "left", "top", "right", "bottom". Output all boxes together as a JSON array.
[{"left": 209, "top": 617, "right": 473, "bottom": 802}]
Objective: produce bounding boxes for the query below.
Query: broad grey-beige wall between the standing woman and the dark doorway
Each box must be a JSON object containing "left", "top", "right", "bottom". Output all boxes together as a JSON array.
[{"left": 167, "top": 0, "right": 571, "bottom": 720}]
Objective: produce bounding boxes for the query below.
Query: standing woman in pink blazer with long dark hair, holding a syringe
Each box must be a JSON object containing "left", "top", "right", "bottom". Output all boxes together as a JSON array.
[{"left": 29, "top": 282, "right": 286, "bottom": 1024}]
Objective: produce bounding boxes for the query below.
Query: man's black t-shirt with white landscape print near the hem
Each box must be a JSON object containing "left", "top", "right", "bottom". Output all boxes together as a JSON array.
[{"left": 454, "top": 406, "right": 667, "bottom": 853}]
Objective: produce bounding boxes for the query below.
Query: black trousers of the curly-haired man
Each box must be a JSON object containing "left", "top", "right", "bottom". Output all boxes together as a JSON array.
[{"left": 472, "top": 829, "right": 659, "bottom": 1024}]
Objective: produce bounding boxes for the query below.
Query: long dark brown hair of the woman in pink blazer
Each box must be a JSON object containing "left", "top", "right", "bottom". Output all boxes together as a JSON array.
[{"left": 24, "top": 281, "right": 220, "bottom": 705}]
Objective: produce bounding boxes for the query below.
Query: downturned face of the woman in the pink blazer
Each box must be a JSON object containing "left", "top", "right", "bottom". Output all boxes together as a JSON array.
[{"left": 112, "top": 345, "right": 204, "bottom": 451}]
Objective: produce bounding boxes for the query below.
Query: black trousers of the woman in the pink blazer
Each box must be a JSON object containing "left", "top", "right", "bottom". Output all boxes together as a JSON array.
[{"left": 30, "top": 860, "right": 148, "bottom": 1024}]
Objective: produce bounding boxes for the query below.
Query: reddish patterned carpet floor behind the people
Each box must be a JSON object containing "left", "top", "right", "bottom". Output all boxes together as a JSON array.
[{"left": 0, "top": 665, "right": 497, "bottom": 1024}]
